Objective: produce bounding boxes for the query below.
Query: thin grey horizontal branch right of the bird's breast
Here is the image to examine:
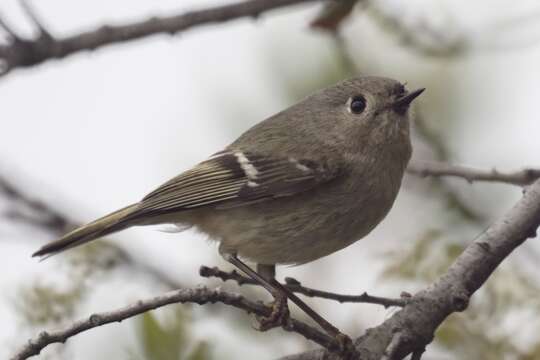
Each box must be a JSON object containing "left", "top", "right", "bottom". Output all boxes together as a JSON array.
[{"left": 407, "top": 162, "right": 540, "bottom": 186}]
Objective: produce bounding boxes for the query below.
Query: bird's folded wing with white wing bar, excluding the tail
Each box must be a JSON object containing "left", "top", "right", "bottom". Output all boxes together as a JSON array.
[{"left": 137, "top": 151, "right": 341, "bottom": 215}]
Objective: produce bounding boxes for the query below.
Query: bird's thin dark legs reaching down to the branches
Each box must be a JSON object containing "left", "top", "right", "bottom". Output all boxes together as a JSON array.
[{"left": 222, "top": 253, "right": 354, "bottom": 352}]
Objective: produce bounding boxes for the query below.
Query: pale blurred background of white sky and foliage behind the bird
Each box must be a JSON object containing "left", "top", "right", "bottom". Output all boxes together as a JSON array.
[{"left": 0, "top": 0, "right": 540, "bottom": 360}]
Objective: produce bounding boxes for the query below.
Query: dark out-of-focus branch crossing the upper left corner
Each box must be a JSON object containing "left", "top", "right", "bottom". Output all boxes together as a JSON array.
[{"left": 0, "top": 0, "right": 322, "bottom": 75}]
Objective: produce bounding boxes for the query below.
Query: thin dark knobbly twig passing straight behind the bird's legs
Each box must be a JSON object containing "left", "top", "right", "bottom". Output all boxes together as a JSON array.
[{"left": 199, "top": 266, "right": 408, "bottom": 308}]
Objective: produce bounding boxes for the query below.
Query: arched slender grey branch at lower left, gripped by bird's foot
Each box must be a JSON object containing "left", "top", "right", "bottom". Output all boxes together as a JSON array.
[{"left": 11, "top": 287, "right": 338, "bottom": 360}]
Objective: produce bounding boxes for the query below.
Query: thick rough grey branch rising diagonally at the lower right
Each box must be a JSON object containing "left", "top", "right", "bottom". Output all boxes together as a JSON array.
[{"left": 282, "top": 179, "right": 540, "bottom": 360}]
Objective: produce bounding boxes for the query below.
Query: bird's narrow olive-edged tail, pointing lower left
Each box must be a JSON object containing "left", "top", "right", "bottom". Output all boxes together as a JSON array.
[{"left": 32, "top": 204, "right": 138, "bottom": 257}]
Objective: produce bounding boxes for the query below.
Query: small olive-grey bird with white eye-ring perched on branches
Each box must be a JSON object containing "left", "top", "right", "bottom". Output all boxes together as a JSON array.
[{"left": 33, "top": 77, "right": 424, "bottom": 344}]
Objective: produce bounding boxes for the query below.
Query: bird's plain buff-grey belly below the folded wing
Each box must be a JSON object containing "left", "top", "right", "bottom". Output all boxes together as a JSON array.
[{"left": 188, "top": 187, "right": 391, "bottom": 264}]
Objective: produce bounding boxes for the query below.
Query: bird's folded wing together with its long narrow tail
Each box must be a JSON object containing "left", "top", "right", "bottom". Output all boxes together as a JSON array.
[{"left": 33, "top": 152, "right": 337, "bottom": 256}]
